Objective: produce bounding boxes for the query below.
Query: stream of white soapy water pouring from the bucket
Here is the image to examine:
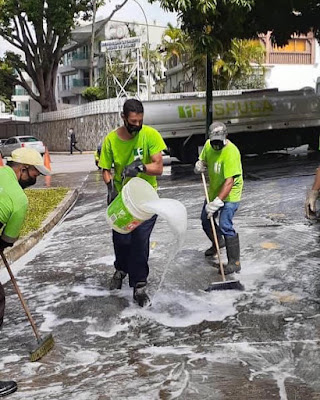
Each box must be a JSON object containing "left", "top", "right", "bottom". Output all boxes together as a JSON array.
[{"left": 140, "top": 199, "right": 187, "bottom": 294}]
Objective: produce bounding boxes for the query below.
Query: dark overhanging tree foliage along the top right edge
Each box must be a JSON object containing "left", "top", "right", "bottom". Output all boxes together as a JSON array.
[{"left": 149, "top": 0, "right": 320, "bottom": 54}]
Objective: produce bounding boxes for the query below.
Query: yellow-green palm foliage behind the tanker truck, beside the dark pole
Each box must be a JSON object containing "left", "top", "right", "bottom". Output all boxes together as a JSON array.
[{"left": 162, "top": 24, "right": 265, "bottom": 91}]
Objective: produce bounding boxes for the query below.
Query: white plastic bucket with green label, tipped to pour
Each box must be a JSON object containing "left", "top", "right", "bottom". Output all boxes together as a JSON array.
[{"left": 107, "top": 178, "right": 159, "bottom": 234}]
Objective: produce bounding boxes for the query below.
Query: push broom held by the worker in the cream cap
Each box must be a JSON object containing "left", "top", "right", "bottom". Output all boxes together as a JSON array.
[{"left": 0, "top": 251, "right": 54, "bottom": 361}]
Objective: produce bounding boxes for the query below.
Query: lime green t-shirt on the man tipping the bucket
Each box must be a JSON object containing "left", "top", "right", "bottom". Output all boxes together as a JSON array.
[{"left": 99, "top": 125, "right": 167, "bottom": 193}]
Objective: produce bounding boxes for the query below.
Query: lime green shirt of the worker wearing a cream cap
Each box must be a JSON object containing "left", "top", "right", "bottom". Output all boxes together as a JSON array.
[{"left": 0, "top": 167, "right": 28, "bottom": 243}]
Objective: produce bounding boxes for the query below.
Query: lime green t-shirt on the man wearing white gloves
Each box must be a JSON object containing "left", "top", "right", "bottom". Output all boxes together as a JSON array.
[{"left": 199, "top": 140, "right": 243, "bottom": 203}]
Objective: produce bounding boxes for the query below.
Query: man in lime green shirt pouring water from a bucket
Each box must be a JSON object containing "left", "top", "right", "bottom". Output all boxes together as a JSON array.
[{"left": 99, "top": 99, "right": 166, "bottom": 307}]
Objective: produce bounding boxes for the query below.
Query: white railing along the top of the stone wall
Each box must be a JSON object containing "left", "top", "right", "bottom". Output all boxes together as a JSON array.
[{"left": 37, "top": 90, "right": 258, "bottom": 122}]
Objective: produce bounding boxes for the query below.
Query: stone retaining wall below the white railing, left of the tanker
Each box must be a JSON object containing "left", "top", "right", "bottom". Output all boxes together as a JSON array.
[{"left": 30, "top": 113, "right": 122, "bottom": 151}]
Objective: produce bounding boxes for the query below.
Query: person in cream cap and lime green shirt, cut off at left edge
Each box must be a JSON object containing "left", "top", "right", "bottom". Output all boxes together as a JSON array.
[{"left": 0, "top": 147, "right": 50, "bottom": 397}]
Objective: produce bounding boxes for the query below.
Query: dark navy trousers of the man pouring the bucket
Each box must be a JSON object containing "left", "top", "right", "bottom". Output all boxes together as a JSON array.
[{"left": 112, "top": 215, "right": 157, "bottom": 287}]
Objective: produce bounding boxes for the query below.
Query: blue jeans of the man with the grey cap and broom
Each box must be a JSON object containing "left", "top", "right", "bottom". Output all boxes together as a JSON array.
[{"left": 201, "top": 201, "right": 240, "bottom": 243}]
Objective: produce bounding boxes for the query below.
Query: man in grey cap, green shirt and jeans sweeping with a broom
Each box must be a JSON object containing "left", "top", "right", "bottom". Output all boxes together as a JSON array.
[{"left": 194, "top": 121, "right": 243, "bottom": 275}]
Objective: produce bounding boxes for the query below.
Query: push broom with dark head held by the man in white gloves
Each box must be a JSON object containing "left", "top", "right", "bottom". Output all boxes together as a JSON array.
[{"left": 201, "top": 172, "right": 244, "bottom": 292}]
